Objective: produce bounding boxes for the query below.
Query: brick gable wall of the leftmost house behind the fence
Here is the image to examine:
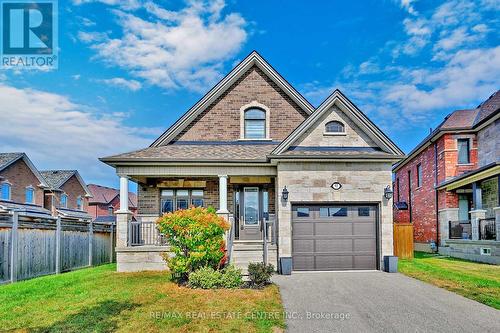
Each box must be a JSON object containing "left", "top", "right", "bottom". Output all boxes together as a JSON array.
[{"left": 0, "top": 159, "right": 43, "bottom": 206}]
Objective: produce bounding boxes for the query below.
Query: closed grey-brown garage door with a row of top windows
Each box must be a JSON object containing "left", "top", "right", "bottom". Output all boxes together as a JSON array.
[{"left": 292, "top": 205, "right": 377, "bottom": 271}]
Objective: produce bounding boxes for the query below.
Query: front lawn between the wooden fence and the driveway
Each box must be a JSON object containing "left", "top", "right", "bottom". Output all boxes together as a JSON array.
[{"left": 0, "top": 265, "right": 285, "bottom": 333}]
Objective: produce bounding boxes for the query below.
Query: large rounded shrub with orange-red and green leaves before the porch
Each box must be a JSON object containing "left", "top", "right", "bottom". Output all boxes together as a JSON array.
[{"left": 157, "top": 207, "right": 229, "bottom": 281}]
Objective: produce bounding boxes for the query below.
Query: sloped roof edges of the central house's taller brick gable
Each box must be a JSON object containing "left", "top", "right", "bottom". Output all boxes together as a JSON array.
[{"left": 150, "top": 51, "right": 314, "bottom": 147}]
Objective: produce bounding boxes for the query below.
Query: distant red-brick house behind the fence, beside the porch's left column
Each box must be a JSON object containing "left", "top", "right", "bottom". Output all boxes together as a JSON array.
[{"left": 87, "top": 184, "right": 137, "bottom": 222}]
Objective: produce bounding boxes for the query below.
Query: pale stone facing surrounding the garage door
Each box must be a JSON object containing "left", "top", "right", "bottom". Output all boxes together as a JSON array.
[{"left": 278, "top": 162, "right": 393, "bottom": 268}]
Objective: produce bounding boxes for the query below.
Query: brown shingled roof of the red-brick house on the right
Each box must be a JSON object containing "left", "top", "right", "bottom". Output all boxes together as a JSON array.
[{"left": 393, "top": 90, "right": 500, "bottom": 172}]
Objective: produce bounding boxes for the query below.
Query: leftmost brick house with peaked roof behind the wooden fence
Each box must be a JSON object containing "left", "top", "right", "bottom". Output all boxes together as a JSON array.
[{"left": 0, "top": 153, "right": 48, "bottom": 207}]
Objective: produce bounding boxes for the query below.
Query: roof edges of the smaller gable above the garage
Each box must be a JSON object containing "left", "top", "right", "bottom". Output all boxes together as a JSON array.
[{"left": 272, "top": 89, "right": 404, "bottom": 158}]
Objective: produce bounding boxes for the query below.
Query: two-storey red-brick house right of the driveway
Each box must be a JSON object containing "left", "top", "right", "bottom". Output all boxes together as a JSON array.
[{"left": 394, "top": 92, "right": 500, "bottom": 262}]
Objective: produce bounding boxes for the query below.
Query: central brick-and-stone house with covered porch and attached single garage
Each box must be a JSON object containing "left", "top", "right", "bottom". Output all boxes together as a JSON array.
[{"left": 101, "top": 52, "right": 403, "bottom": 272}]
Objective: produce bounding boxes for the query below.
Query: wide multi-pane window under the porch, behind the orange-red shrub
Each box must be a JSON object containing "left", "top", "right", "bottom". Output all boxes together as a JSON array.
[{"left": 161, "top": 189, "right": 205, "bottom": 214}]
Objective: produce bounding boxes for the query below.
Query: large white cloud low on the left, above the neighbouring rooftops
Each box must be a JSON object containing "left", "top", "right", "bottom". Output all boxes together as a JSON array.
[{"left": 0, "top": 83, "right": 158, "bottom": 183}]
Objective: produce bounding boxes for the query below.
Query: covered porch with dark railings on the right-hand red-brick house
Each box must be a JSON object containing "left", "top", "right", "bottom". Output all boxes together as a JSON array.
[{"left": 438, "top": 165, "right": 500, "bottom": 264}]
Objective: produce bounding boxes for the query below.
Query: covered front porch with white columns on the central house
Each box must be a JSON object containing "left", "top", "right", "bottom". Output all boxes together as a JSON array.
[{"left": 112, "top": 168, "right": 278, "bottom": 271}]
